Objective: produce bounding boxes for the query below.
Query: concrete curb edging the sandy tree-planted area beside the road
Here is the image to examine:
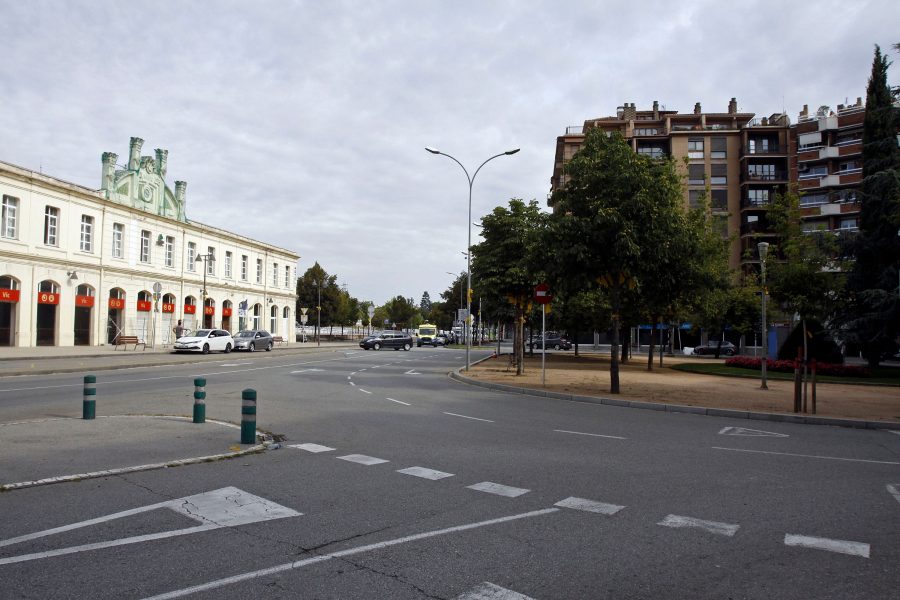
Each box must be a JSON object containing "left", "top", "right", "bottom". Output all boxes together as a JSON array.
[{"left": 450, "top": 357, "right": 900, "bottom": 430}]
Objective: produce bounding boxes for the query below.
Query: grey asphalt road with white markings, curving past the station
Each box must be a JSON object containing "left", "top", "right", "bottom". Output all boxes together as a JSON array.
[{"left": 0, "top": 348, "right": 900, "bottom": 600}]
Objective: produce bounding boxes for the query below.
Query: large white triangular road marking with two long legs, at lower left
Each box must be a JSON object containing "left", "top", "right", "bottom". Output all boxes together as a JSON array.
[{"left": 0, "top": 487, "right": 302, "bottom": 565}]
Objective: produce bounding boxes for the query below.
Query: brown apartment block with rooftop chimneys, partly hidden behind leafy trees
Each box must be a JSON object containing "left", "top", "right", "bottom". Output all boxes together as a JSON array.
[{"left": 550, "top": 98, "right": 790, "bottom": 269}]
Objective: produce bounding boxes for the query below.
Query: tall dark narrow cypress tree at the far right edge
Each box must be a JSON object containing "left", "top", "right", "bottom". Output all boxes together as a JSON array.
[{"left": 842, "top": 46, "right": 900, "bottom": 366}]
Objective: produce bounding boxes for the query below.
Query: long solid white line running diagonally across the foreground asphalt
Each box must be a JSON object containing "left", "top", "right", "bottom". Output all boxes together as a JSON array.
[{"left": 144, "top": 508, "right": 559, "bottom": 600}]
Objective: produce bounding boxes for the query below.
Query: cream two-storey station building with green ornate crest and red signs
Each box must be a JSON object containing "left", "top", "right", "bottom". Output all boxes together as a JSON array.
[{"left": 0, "top": 138, "right": 300, "bottom": 346}]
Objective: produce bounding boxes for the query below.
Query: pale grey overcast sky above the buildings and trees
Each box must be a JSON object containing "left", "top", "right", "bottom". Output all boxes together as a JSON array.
[{"left": 0, "top": 0, "right": 900, "bottom": 304}]
